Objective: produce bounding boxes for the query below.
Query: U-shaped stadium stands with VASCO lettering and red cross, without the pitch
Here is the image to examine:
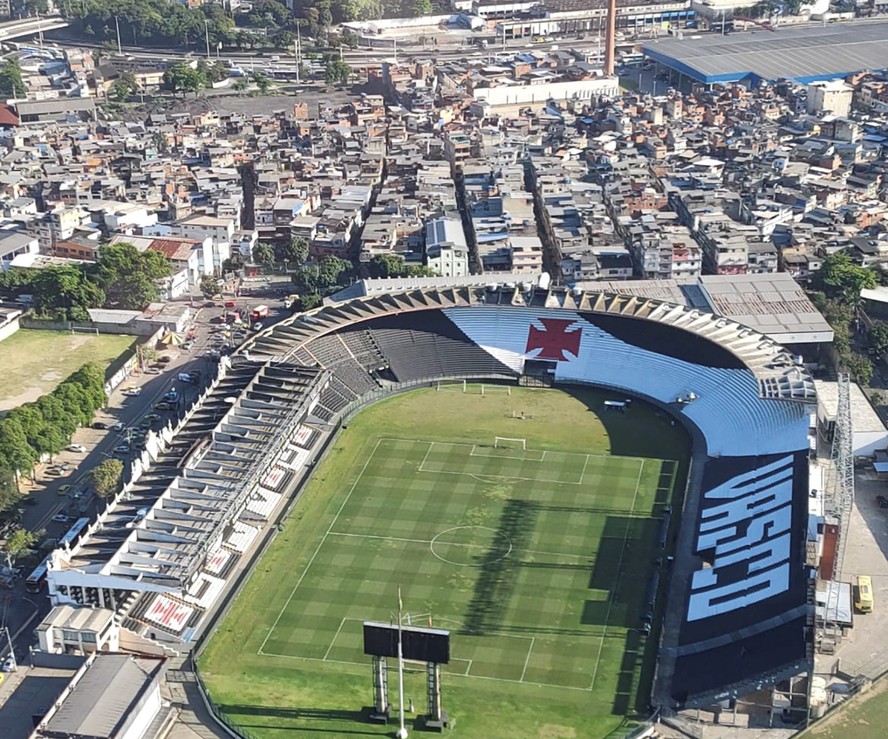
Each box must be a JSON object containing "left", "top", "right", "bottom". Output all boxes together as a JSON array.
[{"left": 49, "top": 285, "right": 815, "bottom": 709}]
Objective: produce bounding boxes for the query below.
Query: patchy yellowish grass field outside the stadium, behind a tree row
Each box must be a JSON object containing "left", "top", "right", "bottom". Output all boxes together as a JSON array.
[{"left": 0, "top": 329, "right": 133, "bottom": 411}]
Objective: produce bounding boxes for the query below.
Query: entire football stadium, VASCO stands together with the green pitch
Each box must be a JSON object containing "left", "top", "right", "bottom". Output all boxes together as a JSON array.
[{"left": 48, "top": 284, "right": 815, "bottom": 737}]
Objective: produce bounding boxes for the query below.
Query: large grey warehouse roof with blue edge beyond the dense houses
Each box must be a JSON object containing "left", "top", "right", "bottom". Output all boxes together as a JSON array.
[{"left": 642, "top": 21, "right": 888, "bottom": 84}]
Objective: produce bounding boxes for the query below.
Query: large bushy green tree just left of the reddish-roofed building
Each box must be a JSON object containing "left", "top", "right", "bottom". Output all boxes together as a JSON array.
[{"left": 93, "top": 242, "right": 173, "bottom": 310}]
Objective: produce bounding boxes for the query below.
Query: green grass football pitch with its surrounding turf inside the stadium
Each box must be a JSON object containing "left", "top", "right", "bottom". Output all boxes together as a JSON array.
[{"left": 200, "top": 386, "right": 687, "bottom": 739}]
